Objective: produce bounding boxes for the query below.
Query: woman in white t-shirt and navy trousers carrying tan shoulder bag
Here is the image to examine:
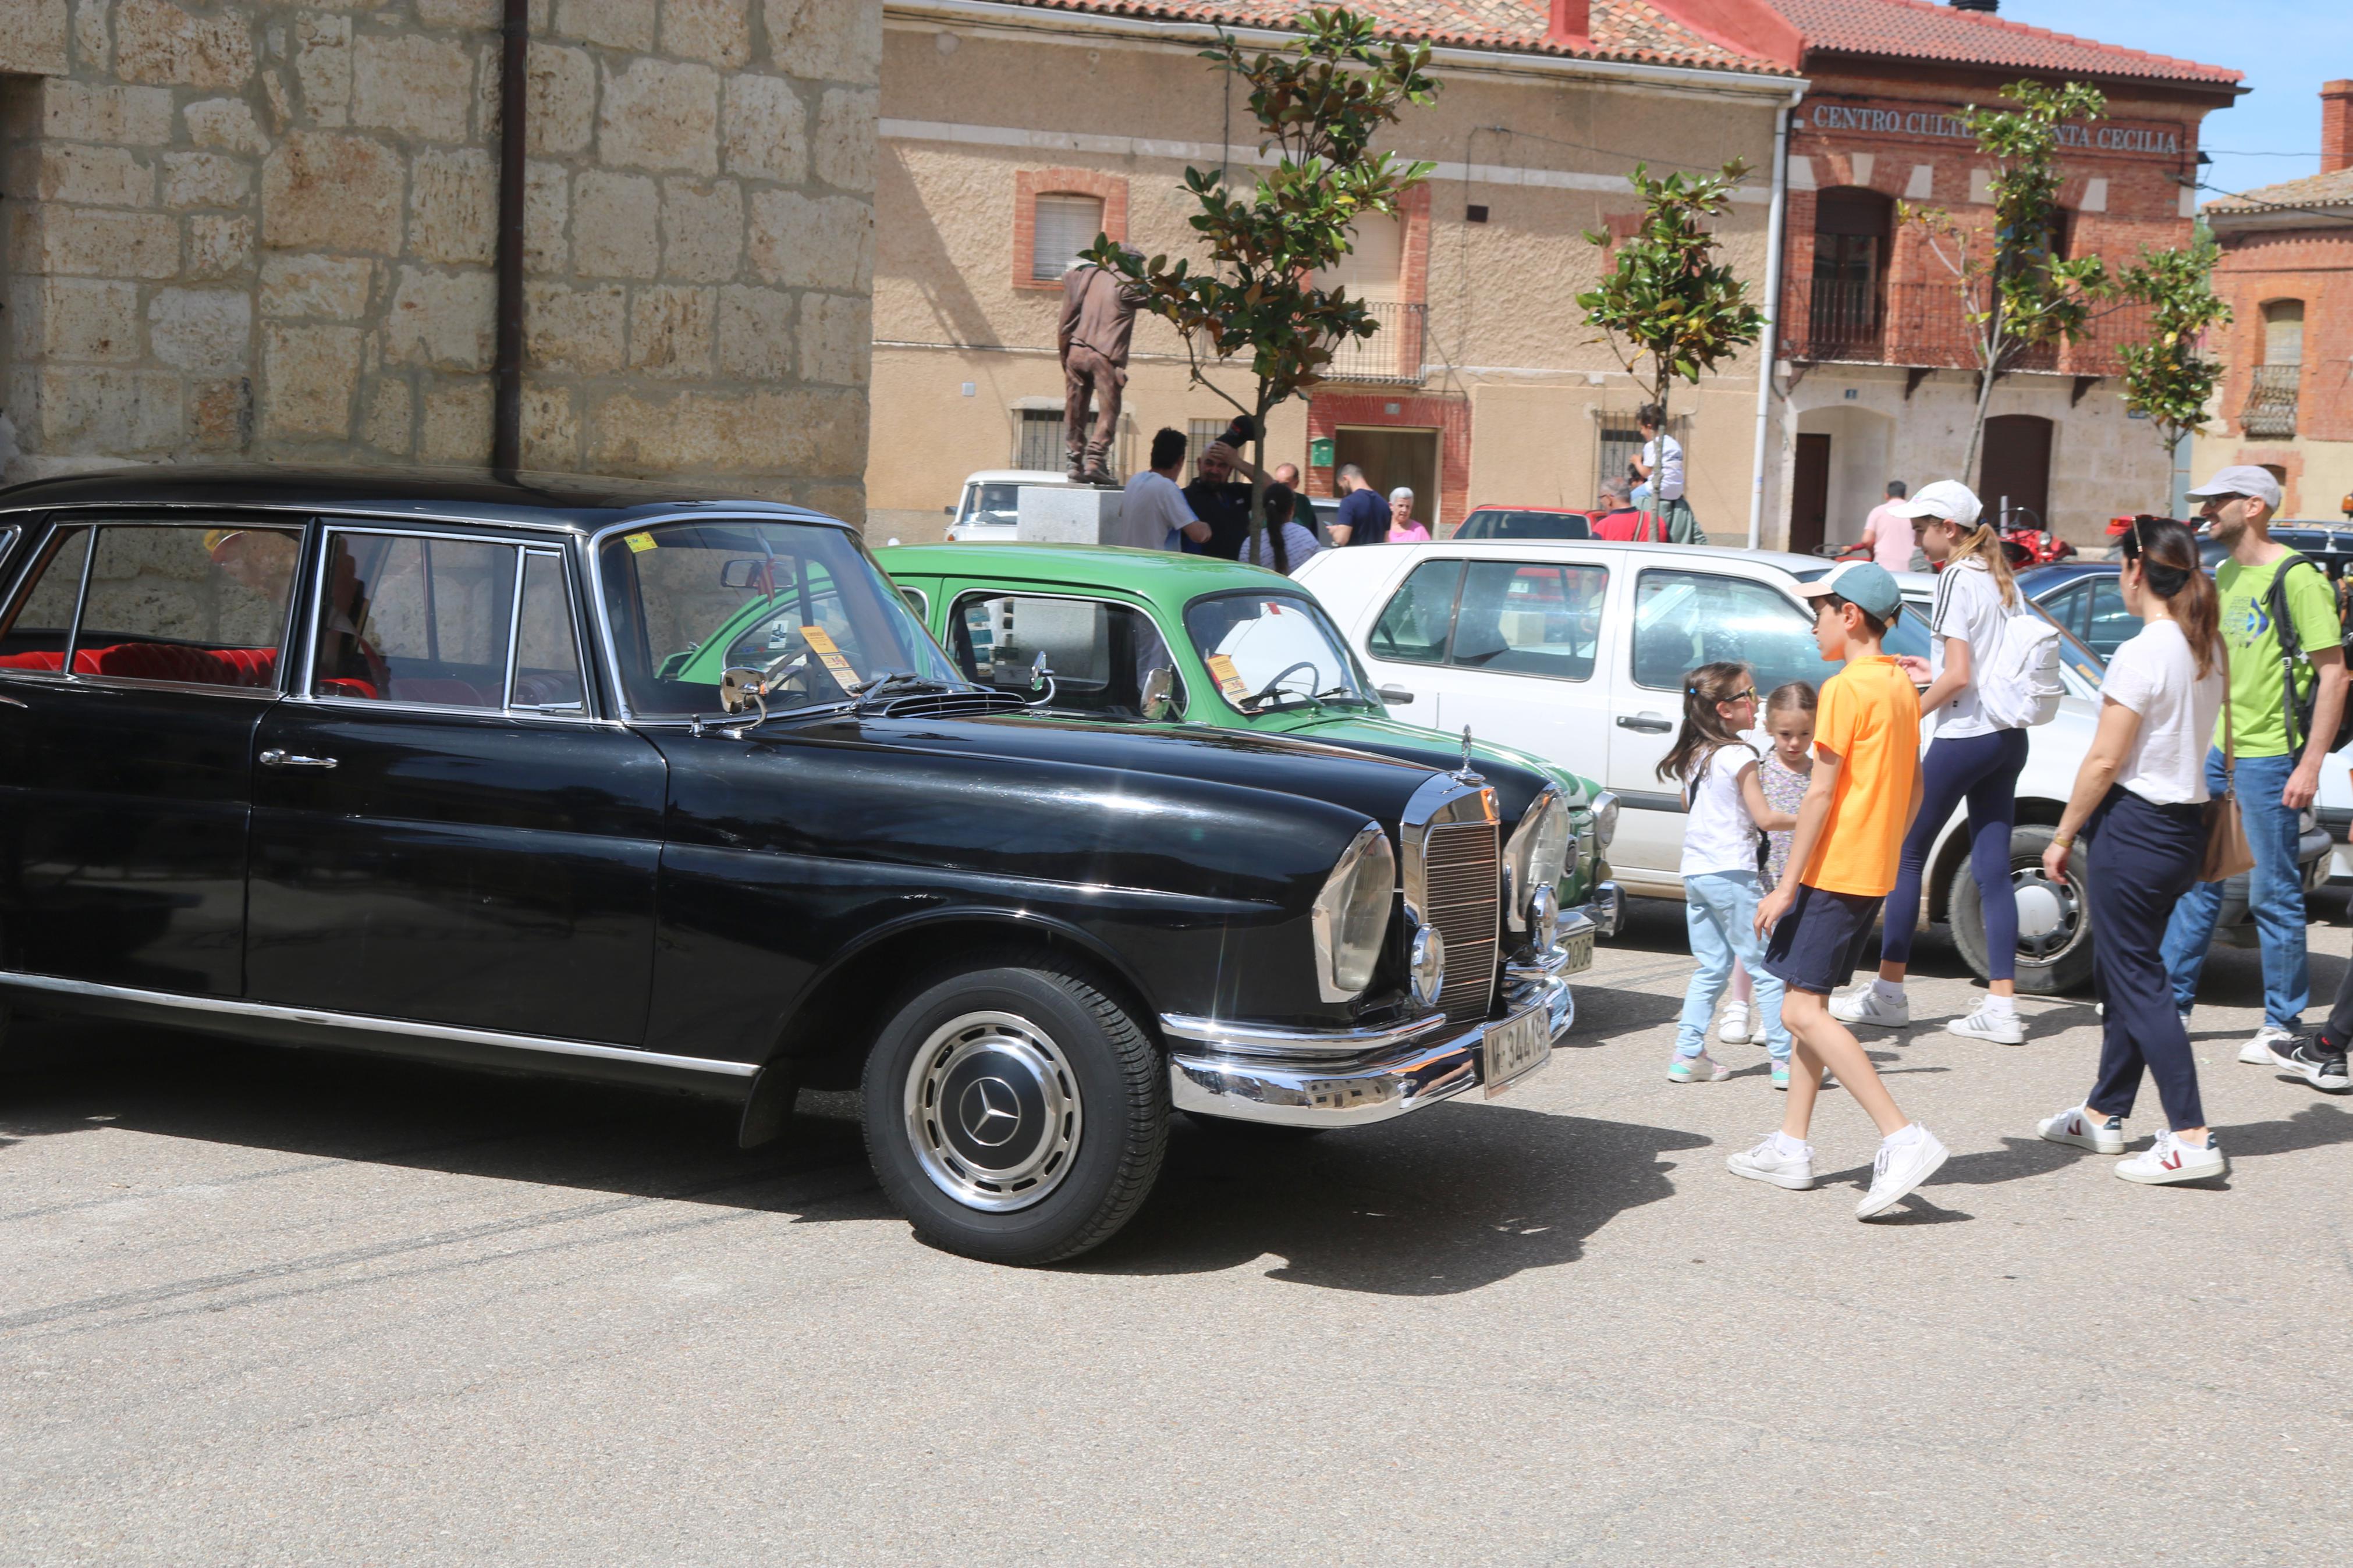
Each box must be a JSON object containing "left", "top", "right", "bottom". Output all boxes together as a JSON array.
[{"left": 2038, "top": 522, "right": 2231, "bottom": 1182}]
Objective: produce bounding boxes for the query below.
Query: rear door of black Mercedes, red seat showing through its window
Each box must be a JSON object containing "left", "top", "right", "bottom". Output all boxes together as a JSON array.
[{"left": 0, "top": 513, "right": 304, "bottom": 997}]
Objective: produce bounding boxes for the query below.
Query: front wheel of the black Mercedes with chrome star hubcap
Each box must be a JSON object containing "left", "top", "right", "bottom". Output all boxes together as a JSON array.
[{"left": 864, "top": 954, "right": 1169, "bottom": 1265}]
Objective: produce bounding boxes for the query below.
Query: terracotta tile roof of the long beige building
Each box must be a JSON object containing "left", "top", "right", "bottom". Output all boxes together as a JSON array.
[{"left": 1012, "top": 0, "right": 1795, "bottom": 75}]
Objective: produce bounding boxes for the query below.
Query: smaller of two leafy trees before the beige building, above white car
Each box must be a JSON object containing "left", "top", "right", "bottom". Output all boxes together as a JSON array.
[{"left": 1577, "top": 158, "right": 1765, "bottom": 541}]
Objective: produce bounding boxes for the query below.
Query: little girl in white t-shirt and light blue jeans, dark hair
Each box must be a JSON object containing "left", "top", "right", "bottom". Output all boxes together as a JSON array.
[{"left": 1659, "top": 663, "right": 1798, "bottom": 1084}]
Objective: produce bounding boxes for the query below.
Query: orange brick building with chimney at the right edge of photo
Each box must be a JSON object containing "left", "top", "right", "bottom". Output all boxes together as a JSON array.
[{"left": 2198, "top": 82, "right": 2353, "bottom": 520}]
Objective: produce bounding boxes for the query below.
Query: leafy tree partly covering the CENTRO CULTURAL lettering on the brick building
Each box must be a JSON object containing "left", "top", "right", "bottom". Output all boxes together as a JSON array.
[{"left": 1897, "top": 82, "right": 2113, "bottom": 475}]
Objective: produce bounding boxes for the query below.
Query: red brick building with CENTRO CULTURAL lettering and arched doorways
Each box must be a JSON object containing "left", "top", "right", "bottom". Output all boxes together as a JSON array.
[{"left": 1741, "top": 0, "right": 2240, "bottom": 550}]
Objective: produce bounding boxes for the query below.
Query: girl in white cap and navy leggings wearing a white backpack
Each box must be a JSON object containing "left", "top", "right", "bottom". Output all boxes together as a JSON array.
[{"left": 1830, "top": 479, "right": 2026, "bottom": 1046}]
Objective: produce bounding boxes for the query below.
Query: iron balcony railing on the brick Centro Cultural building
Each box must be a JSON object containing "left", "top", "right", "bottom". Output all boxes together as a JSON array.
[{"left": 1781, "top": 278, "right": 2148, "bottom": 376}]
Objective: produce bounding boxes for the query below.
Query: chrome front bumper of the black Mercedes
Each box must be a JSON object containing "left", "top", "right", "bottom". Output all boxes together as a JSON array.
[{"left": 1160, "top": 959, "right": 1593, "bottom": 1126}]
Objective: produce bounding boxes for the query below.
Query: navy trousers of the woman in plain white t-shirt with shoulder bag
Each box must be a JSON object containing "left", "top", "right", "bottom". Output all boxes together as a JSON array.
[{"left": 2082, "top": 785, "right": 2205, "bottom": 1130}]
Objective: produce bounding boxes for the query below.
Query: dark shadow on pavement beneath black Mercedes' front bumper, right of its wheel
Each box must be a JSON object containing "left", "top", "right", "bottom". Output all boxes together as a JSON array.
[{"left": 1069, "top": 1105, "right": 1710, "bottom": 1295}]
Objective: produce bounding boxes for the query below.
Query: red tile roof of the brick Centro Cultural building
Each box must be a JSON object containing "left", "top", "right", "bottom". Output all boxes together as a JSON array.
[{"left": 1767, "top": 0, "right": 2245, "bottom": 87}]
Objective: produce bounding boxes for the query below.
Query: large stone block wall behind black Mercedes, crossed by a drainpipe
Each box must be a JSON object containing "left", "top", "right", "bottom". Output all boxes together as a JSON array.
[{"left": 0, "top": 0, "right": 882, "bottom": 517}]
